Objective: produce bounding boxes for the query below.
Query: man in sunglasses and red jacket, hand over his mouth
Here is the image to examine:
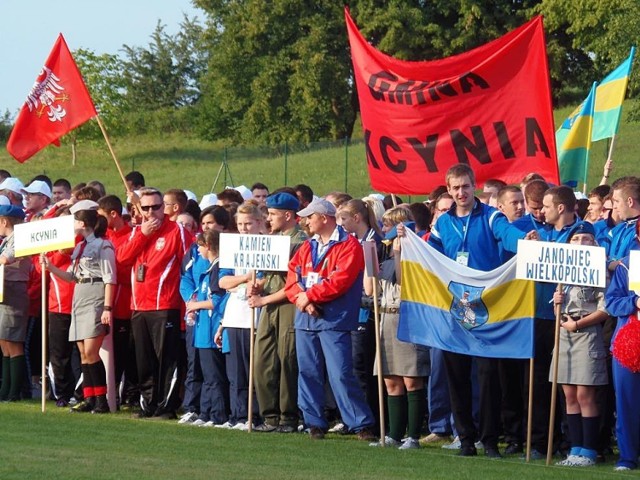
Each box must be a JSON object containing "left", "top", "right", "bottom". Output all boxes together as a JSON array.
[{"left": 116, "top": 188, "right": 188, "bottom": 419}]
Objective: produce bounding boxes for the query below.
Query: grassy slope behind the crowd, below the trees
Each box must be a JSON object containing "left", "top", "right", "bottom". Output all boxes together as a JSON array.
[{"left": 0, "top": 104, "right": 640, "bottom": 200}]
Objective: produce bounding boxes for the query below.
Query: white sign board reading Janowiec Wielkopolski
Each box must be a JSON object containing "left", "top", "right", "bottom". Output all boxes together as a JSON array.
[{"left": 516, "top": 240, "right": 607, "bottom": 288}]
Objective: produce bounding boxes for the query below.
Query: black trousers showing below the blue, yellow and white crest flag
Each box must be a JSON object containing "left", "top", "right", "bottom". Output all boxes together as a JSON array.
[{"left": 444, "top": 352, "right": 500, "bottom": 448}]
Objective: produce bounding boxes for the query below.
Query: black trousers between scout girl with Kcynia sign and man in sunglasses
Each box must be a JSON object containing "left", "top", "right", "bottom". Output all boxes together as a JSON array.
[{"left": 111, "top": 318, "right": 140, "bottom": 403}]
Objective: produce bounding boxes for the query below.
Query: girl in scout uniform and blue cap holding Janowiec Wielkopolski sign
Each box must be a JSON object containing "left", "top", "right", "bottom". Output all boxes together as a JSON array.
[{"left": 549, "top": 222, "right": 609, "bottom": 467}]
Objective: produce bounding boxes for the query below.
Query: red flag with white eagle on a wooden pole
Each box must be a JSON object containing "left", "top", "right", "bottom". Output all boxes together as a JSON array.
[{"left": 7, "top": 34, "right": 98, "bottom": 162}]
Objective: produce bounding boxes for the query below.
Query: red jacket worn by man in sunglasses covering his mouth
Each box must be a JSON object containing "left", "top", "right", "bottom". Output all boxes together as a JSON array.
[{"left": 116, "top": 217, "right": 189, "bottom": 311}]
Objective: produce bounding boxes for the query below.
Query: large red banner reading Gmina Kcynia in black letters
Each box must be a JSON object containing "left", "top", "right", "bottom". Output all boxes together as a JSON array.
[{"left": 345, "top": 9, "right": 559, "bottom": 194}]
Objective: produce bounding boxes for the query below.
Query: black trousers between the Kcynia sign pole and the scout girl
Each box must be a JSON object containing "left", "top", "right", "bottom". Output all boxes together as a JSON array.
[{"left": 49, "top": 312, "right": 78, "bottom": 401}]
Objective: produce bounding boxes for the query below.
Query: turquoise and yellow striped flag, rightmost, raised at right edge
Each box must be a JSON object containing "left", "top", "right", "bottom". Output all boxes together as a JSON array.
[{"left": 591, "top": 47, "right": 636, "bottom": 142}]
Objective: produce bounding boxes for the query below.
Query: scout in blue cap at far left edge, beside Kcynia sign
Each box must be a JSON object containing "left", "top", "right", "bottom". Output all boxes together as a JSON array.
[{"left": 0, "top": 202, "right": 31, "bottom": 401}]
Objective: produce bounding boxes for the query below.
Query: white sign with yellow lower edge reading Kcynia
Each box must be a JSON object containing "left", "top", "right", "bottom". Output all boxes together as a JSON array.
[{"left": 14, "top": 215, "right": 76, "bottom": 257}]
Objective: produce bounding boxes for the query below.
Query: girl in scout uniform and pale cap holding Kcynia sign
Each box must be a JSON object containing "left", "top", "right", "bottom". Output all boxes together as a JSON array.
[{"left": 41, "top": 200, "right": 116, "bottom": 413}]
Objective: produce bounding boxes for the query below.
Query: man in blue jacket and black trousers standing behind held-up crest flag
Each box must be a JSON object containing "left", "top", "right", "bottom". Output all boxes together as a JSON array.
[{"left": 428, "top": 163, "right": 537, "bottom": 458}]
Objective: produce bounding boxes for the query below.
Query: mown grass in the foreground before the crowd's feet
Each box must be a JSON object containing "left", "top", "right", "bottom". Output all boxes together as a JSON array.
[{"left": 0, "top": 400, "right": 640, "bottom": 480}]
